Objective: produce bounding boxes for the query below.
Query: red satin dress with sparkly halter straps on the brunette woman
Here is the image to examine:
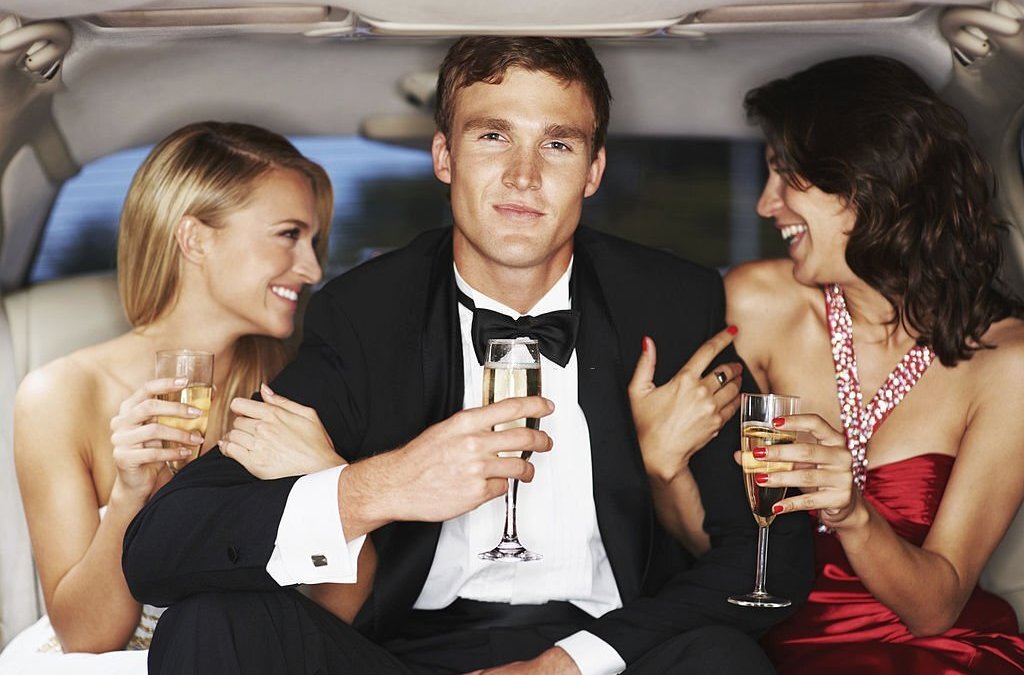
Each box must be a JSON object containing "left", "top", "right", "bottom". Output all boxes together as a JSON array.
[{"left": 762, "top": 287, "right": 1024, "bottom": 675}]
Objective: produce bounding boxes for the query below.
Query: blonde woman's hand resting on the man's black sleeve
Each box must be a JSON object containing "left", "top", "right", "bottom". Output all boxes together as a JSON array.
[{"left": 220, "top": 384, "right": 346, "bottom": 480}]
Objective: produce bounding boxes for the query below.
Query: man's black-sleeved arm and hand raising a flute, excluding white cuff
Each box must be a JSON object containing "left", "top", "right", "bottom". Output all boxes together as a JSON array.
[{"left": 123, "top": 396, "right": 554, "bottom": 604}]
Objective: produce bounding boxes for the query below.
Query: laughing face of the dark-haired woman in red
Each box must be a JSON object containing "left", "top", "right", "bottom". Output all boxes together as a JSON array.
[{"left": 757, "top": 150, "right": 856, "bottom": 286}]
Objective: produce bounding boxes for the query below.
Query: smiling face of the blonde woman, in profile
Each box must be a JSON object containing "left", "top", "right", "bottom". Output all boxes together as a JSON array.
[{"left": 204, "top": 169, "right": 322, "bottom": 338}]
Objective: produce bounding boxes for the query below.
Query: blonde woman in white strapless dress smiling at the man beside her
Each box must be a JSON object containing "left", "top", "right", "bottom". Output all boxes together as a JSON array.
[{"left": 0, "top": 122, "right": 340, "bottom": 673}]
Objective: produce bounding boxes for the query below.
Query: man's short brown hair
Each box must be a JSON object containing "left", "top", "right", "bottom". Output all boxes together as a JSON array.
[{"left": 434, "top": 36, "right": 611, "bottom": 156}]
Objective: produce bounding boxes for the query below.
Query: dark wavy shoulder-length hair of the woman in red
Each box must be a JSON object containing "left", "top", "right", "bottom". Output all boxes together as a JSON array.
[{"left": 744, "top": 56, "right": 1021, "bottom": 367}]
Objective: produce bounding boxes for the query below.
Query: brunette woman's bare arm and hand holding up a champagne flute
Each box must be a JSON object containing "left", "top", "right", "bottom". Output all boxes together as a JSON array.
[{"left": 767, "top": 347, "right": 1024, "bottom": 635}]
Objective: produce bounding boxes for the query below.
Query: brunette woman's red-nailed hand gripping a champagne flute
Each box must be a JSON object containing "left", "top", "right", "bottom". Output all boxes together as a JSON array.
[{"left": 737, "top": 413, "right": 861, "bottom": 529}]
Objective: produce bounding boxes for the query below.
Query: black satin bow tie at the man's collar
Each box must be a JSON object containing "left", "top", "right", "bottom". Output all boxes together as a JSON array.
[{"left": 458, "top": 291, "right": 580, "bottom": 368}]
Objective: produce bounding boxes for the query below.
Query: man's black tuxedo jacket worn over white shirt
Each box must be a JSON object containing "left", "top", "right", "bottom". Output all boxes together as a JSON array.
[{"left": 124, "top": 228, "right": 813, "bottom": 663}]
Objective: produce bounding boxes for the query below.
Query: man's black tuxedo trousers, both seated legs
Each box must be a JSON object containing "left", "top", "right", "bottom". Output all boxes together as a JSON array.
[{"left": 148, "top": 591, "right": 775, "bottom": 675}]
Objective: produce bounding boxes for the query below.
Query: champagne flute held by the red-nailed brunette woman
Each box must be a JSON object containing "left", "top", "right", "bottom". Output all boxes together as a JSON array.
[{"left": 729, "top": 393, "right": 800, "bottom": 607}]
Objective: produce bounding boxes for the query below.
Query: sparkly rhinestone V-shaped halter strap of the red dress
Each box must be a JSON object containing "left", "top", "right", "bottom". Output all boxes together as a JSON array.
[{"left": 824, "top": 284, "right": 935, "bottom": 492}]
